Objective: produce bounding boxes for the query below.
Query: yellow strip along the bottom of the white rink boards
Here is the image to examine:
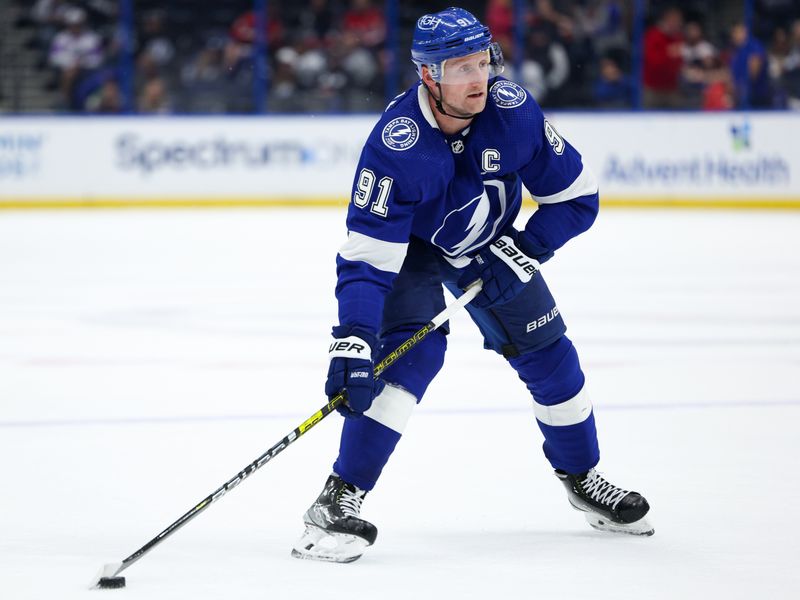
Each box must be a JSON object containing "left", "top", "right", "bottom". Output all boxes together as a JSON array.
[{"left": 0, "top": 196, "right": 800, "bottom": 210}]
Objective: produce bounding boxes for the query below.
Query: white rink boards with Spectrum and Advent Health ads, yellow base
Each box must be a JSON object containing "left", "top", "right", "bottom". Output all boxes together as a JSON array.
[{"left": 0, "top": 112, "right": 800, "bottom": 209}]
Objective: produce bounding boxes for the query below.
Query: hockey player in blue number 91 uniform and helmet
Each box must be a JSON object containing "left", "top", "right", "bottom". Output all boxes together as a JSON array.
[{"left": 292, "top": 8, "right": 653, "bottom": 562}]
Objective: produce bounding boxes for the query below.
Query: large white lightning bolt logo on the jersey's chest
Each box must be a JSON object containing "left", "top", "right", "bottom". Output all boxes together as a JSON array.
[{"left": 431, "top": 179, "right": 506, "bottom": 258}]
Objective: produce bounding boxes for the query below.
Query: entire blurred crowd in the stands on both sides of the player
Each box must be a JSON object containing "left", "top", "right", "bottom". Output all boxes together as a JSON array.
[{"left": 6, "top": 0, "right": 800, "bottom": 113}]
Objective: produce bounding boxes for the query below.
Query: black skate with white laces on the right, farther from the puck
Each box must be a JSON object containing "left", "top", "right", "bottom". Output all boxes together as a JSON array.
[{"left": 556, "top": 469, "right": 655, "bottom": 535}]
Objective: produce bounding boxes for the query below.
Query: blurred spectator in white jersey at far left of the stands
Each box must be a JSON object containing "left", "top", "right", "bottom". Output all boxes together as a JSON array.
[{"left": 49, "top": 7, "right": 103, "bottom": 110}]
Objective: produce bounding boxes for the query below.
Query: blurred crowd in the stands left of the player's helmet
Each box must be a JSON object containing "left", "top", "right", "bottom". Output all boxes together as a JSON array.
[{"left": 9, "top": 0, "right": 388, "bottom": 113}]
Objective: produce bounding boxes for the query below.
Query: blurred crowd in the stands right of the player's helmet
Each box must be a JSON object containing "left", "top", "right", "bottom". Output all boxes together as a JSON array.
[{"left": 486, "top": 0, "right": 800, "bottom": 110}]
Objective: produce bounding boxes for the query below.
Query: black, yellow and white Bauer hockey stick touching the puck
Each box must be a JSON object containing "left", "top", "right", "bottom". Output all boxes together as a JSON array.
[{"left": 89, "top": 281, "right": 483, "bottom": 589}]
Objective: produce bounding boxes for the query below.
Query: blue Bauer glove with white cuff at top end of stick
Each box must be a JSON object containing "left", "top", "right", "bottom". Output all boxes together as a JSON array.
[{"left": 457, "top": 232, "right": 539, "bottom": 308}]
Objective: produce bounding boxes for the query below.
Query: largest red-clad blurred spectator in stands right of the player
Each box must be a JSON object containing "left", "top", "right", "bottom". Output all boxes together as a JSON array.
[{"left": 643, "top": 6, "right": 683, "bottom": 109}]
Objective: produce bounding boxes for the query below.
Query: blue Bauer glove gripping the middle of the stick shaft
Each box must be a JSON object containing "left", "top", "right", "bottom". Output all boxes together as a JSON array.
[{"left": 325, "top": 325, "right": 384, "bottom": 417}]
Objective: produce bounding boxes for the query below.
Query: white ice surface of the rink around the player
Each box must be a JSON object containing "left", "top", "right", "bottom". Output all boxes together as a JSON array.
[{"left": 0, "top": 210, "right": 800, "bottom": 600}]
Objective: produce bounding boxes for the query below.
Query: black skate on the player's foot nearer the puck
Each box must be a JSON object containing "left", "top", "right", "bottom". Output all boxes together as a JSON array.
[{"left": 292, "top": 473, "right": 378, "bottom": 563}]
